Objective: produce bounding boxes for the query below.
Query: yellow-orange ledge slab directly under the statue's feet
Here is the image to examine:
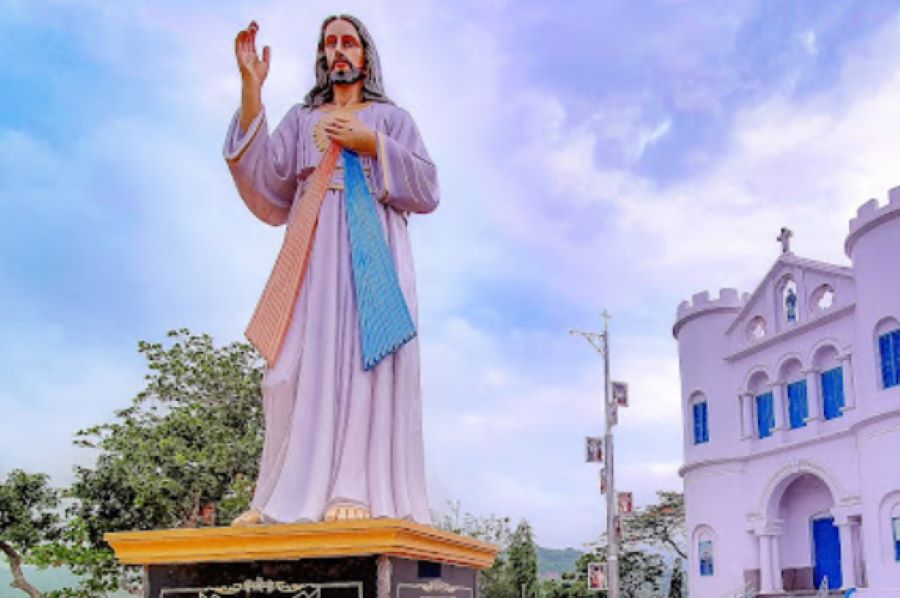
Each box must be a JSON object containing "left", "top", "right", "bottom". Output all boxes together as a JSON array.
[{"left": 104, "top": 519, "right": 499, "bottom": 569}]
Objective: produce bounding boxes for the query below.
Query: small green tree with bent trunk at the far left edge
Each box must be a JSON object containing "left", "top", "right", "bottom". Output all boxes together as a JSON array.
[{"left": 0, "top": 469, "right": 60, "bottom": 598}]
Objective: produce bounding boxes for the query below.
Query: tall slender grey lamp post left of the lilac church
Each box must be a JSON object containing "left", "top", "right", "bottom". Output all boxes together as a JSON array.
[{"left": 569, "top": 309, "right": 619, "bottom": 598}]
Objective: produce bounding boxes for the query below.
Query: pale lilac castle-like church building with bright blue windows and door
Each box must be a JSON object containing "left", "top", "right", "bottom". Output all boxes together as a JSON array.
[{"left": 674, "top": 188, "right": 900, "bottom": 598}]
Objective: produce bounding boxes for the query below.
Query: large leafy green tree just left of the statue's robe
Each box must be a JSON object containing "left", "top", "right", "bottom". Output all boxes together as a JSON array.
[{"left": 36, "top": 329, "right": 264, "bottom": 596}]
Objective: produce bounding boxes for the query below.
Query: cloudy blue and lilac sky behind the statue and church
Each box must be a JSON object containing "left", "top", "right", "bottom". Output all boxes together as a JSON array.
[{"left": 0, "top": 0, "right": 900, "bottom": 547}]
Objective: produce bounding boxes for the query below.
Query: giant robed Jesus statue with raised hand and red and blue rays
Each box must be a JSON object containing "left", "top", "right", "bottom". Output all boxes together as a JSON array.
[{"left": 224, "top": 15, "right": 439, "bottom": 525}]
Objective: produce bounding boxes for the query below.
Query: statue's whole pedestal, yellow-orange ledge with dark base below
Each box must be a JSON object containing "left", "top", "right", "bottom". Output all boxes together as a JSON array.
[{"left": 106, "top": 520, "right": 498, "bottom": 598}]
